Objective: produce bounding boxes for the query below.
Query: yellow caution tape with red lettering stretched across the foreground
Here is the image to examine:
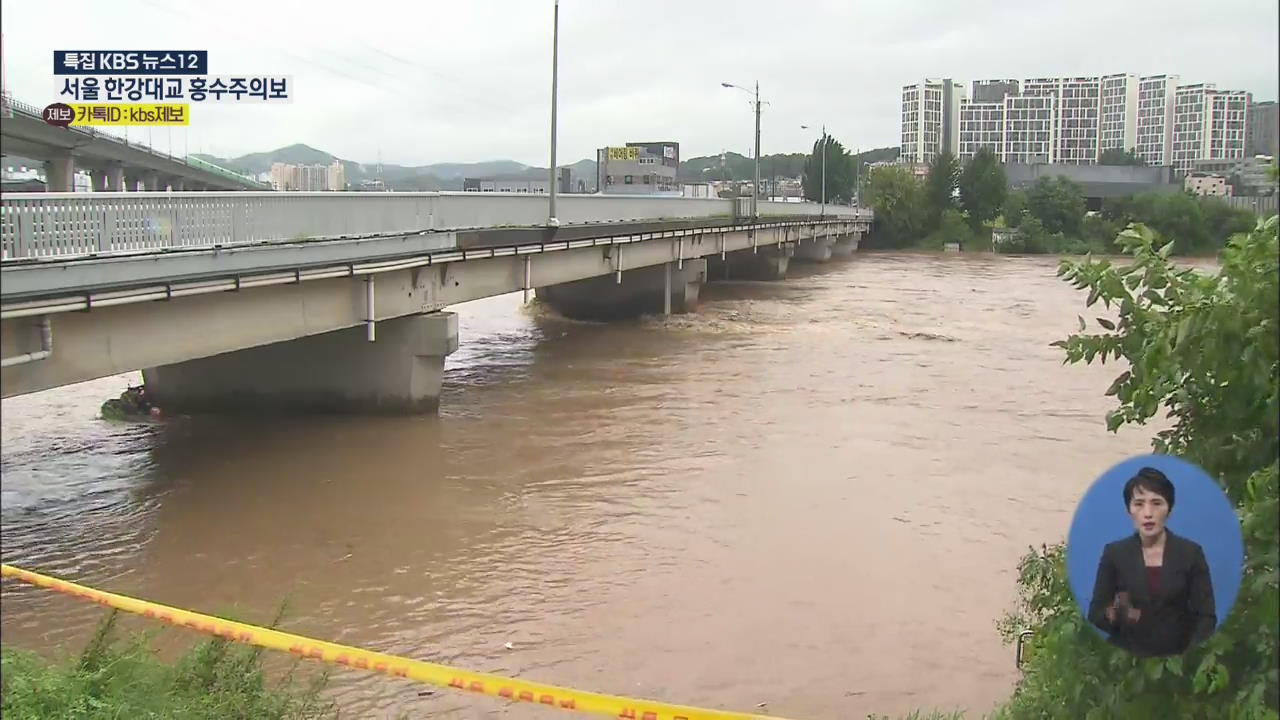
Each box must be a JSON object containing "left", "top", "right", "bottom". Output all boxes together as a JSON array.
[{"left": 0, "top": 565, "right": 778, "bottom": 720}]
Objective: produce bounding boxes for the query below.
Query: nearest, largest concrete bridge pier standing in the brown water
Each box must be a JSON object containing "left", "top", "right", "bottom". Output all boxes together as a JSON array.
[{"left": 142, "top": 313, "right": 458, "bottom": 414}]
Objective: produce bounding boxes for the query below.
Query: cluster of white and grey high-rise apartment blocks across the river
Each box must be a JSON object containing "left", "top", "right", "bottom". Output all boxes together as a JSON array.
[{"left": 916, "top": 73, "right": 1254, "bottom": 173}]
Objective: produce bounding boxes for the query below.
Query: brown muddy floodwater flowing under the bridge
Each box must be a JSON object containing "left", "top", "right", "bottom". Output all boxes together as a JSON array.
[{"left": 0, "top": 254, "right": 1151, "bottom": 719}]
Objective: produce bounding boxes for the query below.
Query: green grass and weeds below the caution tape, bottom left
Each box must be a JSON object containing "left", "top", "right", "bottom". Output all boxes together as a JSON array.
[{"left": 0, "top": 611, "right": 337, "bottom": 720}]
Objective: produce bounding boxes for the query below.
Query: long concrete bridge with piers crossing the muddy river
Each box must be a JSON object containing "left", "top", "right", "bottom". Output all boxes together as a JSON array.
[{"left": 0, "top": 192, "right": 872, "bottom": 413}]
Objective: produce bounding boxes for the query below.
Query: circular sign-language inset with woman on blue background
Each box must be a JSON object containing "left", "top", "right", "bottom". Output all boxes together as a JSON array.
[{"left": 1066, "top": 455, "right": 1244, "bottom": 657}]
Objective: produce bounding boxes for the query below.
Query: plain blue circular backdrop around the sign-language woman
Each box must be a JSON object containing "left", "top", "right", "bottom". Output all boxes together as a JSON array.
[{"left": 1066, "top": 455, "right": 1244, "bottom": 634}]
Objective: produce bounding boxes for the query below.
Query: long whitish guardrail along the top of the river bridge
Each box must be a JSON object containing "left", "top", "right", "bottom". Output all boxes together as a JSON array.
[{"left": 0, "top": 192, "right": 872, "bottom": 260}]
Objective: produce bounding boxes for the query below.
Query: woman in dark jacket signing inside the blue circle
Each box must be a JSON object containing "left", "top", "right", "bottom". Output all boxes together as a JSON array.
[{"left": 1089, "top": 468, "right": 1217, "bottom": 656}]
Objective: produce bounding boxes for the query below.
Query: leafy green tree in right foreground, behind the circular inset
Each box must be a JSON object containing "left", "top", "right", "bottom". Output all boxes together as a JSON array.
[{"left": 997, "top": 218, "right": 1280, "bottom": 720}]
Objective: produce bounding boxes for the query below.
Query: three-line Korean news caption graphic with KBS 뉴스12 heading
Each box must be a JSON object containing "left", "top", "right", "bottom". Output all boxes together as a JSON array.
[{"left": 44, "top": 50, "right": 293, "bottom": 127}]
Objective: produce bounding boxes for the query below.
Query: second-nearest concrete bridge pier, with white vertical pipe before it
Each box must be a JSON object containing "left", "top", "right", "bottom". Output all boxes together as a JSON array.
[{"left": 535, "top": 259, "right": 707, "bottom": 320}]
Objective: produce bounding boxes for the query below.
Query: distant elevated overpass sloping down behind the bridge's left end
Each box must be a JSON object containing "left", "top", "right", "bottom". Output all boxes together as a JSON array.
[{"left": 0, "top": 96, "right": 270, "bottom": 192}]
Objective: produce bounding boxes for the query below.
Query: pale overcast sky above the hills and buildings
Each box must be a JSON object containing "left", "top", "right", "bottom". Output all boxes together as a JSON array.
[{"left": 3, "top": 0, "right": 1280, "bottom": 167}]
